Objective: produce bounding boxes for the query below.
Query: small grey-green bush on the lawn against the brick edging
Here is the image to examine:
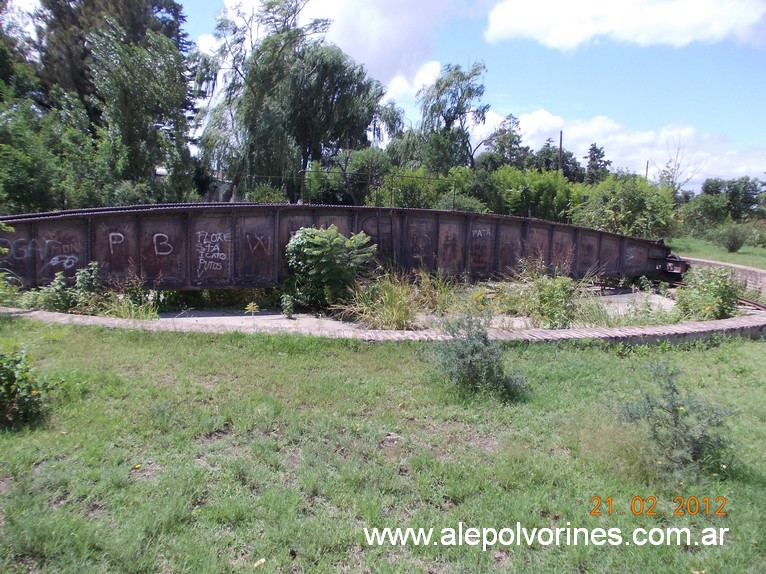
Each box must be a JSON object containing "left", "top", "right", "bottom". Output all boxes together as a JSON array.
[{"left": 433, "top": 313, "right": 526, "bottom": 400}]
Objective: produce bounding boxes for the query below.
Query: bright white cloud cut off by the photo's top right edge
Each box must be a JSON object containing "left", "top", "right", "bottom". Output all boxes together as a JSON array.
[{"left": 485, "top": 0, "right": 766, "bottom": 50}]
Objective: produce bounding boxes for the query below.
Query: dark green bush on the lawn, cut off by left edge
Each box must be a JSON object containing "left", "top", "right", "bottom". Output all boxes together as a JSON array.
[{"left": 0, "top": 352, "right": 49, "bottom": 427}]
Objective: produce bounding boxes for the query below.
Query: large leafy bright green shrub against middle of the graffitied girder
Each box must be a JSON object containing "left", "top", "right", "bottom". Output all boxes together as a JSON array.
[{"left": 287, "top": 225, "right": 377, "bottom": 309}]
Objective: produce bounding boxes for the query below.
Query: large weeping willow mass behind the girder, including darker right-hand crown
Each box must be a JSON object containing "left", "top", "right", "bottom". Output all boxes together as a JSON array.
[{"left": 200, "top": 0, "right": 396, "bottom": 204}]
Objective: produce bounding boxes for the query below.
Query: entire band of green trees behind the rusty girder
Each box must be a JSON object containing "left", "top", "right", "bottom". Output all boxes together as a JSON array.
[{"left": 0, "top": 0, "right": 764, "bottom": 241}]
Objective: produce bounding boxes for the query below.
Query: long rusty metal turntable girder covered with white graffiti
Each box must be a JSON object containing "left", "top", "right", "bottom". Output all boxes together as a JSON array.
[{"left": 0, "top": 204, "right": 670, "bottom": 289}]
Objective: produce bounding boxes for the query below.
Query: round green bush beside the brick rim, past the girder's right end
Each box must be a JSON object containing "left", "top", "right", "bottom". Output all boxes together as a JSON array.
[{"left": 676, "top": 267, "right": 741, "bottom": 321}]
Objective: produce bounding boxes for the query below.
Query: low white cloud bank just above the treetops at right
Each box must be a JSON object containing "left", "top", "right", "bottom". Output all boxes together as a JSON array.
[{"left": 519, "top": 109, "right": 766, "bottom": 194}]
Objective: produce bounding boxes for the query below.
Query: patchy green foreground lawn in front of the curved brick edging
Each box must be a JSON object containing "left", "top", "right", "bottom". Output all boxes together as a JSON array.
[{"left": 0, "top": 318, "right": 766, "bottom": 574}]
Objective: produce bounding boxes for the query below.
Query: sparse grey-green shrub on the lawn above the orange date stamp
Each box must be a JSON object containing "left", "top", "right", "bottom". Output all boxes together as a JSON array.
[{"left": 621, "top": 365, "right": 733, "bottom": 480}]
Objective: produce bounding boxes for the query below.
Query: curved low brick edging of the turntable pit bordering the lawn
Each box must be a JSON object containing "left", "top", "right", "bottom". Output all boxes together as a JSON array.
[{"left": 0, "top": 307, "right": 766, "bottom": 344}]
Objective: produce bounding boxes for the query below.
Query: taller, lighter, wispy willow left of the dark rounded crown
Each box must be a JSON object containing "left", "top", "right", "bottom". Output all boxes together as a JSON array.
[{"left": 198, "top": 0, "right": 329, "bottom": 196}]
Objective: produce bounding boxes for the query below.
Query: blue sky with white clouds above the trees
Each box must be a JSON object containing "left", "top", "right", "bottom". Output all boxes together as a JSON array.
[{"left": 7, "top": 0, "right": 766, "bottom": 194}]
